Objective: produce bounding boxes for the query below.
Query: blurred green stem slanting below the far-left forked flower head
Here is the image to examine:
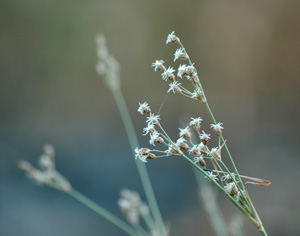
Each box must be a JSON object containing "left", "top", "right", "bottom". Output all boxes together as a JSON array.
[{"left": 68, "top": 189, "right": 139, "bottom": 236}]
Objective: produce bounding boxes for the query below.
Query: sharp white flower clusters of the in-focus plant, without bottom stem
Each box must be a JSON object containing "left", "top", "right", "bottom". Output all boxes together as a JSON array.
[{"left": 141, "top": 31, "right": 253, "bottom": 211}]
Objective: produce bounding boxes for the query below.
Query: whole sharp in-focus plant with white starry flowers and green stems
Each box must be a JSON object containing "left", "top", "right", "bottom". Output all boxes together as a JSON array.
[{"left": 136, "top": 32, "right": 270, "bottom": 235}]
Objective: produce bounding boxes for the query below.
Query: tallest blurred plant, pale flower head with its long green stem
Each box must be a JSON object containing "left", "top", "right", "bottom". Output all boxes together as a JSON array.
[{"left": 96, "top": 35, "right": 166, "bottom": 235}]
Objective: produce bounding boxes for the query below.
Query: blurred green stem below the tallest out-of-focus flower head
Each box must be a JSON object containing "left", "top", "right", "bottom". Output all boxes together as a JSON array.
[{"left": 112, "top": 90, "right": 165, "bottom": 232}]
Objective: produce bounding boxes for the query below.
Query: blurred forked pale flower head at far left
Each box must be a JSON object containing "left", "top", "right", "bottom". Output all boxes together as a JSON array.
[{"left": 18, "top": 144, "right": 72, "bottom": 192}]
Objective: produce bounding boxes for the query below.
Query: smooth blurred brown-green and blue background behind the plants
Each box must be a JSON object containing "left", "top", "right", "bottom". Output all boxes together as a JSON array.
[{"left": 0, "top": 0, "right": 300, "bottom": 236}]
